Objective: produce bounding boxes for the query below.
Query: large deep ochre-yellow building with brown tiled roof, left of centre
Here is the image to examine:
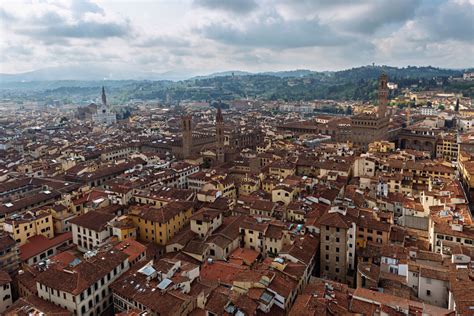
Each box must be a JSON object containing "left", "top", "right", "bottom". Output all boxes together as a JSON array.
[{"left": 129, "top": 202, "right": 194, "bottom": 245}]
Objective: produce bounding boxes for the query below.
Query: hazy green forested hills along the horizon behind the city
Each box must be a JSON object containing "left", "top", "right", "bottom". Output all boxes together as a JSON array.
[{"left": 1, "top": 66, "right": 474, "bottom": 103}]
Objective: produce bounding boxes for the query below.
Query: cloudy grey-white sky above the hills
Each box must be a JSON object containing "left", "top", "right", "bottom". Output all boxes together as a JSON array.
[{"left": 0, "top": 0, "right": 474, "bottom": 75}]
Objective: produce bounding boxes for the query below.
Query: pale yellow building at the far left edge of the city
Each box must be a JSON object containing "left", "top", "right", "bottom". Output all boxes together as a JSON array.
[{"left": 3, "top": 209, "right": 54, "bottom": 246}]
